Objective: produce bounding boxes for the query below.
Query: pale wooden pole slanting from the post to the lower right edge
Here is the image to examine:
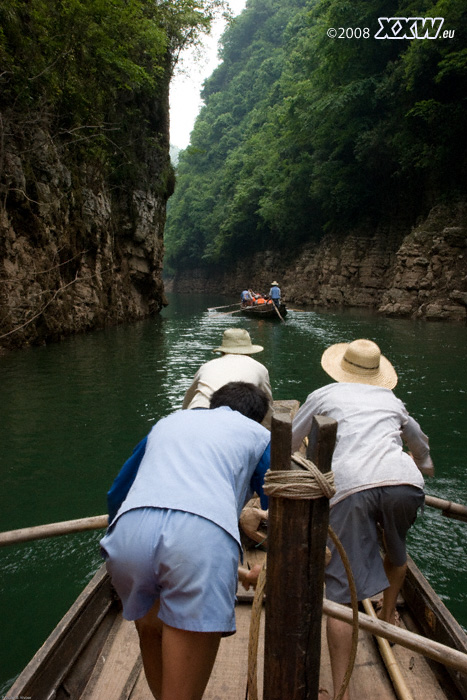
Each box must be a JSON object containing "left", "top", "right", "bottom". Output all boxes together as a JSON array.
[{"left": 323, "top": 599, "right": 467, "bottom": 673}]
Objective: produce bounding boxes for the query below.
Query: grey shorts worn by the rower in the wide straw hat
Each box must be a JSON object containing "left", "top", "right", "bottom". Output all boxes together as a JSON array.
[{"left": 325, "top": 484, "right": 425, "bottom": 603}]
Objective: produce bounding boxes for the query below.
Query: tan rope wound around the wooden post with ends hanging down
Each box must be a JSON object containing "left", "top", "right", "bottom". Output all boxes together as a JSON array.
[{"left": 245, "top": 452, "right": 358, "bottom": 700}]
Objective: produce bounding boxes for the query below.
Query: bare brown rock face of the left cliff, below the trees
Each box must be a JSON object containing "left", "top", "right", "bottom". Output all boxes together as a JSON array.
[{"left": 0, "top": 119, "right": 173, "bottom": 356}]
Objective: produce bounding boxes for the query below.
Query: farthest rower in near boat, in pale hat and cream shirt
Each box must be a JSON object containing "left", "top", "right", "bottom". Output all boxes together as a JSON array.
[{"left": 182, "top": 328, "right": 272, "bottom": 427}]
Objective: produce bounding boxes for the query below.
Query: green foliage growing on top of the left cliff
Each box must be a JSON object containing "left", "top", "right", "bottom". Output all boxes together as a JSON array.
[{"left": 0, "top": 0, "right": 221, "bottom": 191}]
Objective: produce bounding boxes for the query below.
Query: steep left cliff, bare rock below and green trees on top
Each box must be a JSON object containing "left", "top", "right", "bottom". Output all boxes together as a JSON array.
[{"left": 0, "top": 0, "right": 227, "bottom": 347}]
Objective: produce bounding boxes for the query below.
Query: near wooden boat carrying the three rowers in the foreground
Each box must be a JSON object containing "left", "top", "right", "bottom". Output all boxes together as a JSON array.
[{"left": 6, "top": 402, "right": 467, "bottom": 700}]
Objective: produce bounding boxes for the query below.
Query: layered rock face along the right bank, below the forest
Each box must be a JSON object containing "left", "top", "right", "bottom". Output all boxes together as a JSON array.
[{"left": 172, "top": 205, "right": 467, "bottom": 322}]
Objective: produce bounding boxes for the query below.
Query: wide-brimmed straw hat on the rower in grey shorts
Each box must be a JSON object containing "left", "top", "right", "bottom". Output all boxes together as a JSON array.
[{"left": 321, "top": 339, "right": 397, "bottom": 389}]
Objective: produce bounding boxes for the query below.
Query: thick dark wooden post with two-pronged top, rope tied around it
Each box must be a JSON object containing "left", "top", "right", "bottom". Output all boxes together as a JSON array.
[{"left": 263, "top": 414, "right": 337, "bottom": 700}]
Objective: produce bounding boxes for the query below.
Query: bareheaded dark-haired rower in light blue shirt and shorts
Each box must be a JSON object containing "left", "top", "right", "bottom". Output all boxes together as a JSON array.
[{"left": 100, "top": 382, "right": 270, "bottom": 700}]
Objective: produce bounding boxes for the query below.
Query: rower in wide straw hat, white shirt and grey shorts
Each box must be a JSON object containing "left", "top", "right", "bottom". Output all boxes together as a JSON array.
[{"left": 292, "top": 339, "right": 434, "bottom": 700}]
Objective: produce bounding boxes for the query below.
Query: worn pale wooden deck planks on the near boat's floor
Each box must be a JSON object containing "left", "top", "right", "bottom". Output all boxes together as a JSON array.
[{"left": 66, "top": 592, "right": 464, "bottom": 700}]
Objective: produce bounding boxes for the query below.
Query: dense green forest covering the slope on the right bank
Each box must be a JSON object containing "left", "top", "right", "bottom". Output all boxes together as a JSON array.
[{"left": 165, "top": 0, "right": 467, "bottom": 271}]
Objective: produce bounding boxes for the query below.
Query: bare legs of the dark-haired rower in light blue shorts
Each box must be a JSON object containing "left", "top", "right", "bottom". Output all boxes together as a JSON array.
[{"left": 136, "top": 601, "right": 221, "bottom": 700}]
